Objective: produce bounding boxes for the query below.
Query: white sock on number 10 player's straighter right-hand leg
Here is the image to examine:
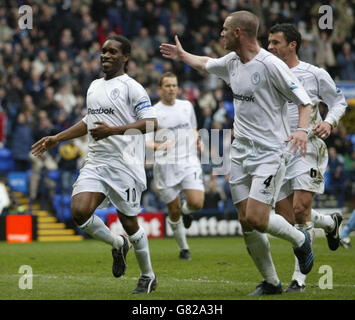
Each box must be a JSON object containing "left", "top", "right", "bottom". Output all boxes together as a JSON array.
[{"left": 128, "top": 226, "right": 154, "bottom": 278}]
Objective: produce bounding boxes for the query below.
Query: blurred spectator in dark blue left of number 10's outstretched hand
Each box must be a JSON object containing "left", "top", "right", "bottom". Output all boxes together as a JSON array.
[{"left": 11, "top": 112, "right": 34, "bottom": 171}]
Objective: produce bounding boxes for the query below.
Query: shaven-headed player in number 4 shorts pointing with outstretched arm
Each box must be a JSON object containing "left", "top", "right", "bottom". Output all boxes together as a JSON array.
[{"left": 160, "top": 11, "right": 314, "bottom": 295}]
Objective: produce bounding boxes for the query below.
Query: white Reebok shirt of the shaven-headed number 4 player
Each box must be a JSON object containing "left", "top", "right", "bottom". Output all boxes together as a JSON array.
[{"left": 206, "top": 49, "right": 311, "bottom": 147}]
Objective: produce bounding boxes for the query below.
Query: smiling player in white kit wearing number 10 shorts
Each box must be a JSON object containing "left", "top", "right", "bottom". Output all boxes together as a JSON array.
[{"left": 32, "top": 35, "right": 157, "bottom": 293}]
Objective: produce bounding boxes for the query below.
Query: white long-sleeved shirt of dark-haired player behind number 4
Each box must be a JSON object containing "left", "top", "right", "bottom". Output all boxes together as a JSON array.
[{"left": 288, "top": 61, "right": 347, "bottom": 132}]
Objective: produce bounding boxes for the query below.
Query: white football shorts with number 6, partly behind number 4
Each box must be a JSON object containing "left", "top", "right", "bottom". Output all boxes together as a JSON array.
[{"left": 277, "top": 136, "right": 328, "bottom": 201}]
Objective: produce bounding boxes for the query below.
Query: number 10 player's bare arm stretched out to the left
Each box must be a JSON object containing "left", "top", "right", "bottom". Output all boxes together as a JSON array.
[{"left": 31, "top": 121, "right": 87, "bottom": 156}]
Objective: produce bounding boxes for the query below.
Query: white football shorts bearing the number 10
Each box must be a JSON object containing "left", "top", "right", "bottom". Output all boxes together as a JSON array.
[{"left": 72, "top": 164, "right": 142, "bottom": 216}]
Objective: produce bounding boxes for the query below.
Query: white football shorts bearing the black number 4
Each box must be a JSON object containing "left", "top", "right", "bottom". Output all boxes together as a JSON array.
[{"left": 229, "top": 138, "right": 286, "bottom": 205}]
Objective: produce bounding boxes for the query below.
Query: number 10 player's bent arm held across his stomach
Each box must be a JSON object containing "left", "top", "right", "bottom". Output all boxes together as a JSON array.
[{"left": 89, "top": 118, "right": 158, "bottom": 141}]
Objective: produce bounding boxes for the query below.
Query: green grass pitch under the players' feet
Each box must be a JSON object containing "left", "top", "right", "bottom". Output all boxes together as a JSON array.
[{"left": 0, "top": 237, "right": 355, "bottom": 300}]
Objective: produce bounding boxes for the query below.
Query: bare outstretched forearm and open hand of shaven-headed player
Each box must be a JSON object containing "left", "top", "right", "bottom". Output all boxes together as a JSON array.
[{"left": 160, "top": 36, "right": 209, "bottom": 71}]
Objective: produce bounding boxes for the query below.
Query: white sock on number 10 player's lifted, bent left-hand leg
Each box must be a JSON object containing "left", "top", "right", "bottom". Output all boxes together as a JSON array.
[{"left": 79, "top": 214, "right": 123, "bottom": 249}]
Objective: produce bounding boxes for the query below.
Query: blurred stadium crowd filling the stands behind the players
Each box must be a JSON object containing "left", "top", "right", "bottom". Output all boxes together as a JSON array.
[{"left": 0, "top": 0, "right": 355, "bottom": 212}]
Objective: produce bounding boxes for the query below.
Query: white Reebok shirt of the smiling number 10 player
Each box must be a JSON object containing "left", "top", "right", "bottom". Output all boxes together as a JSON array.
[{"left": 83, "top": 74, "right": 156, "bottom": 190}]
